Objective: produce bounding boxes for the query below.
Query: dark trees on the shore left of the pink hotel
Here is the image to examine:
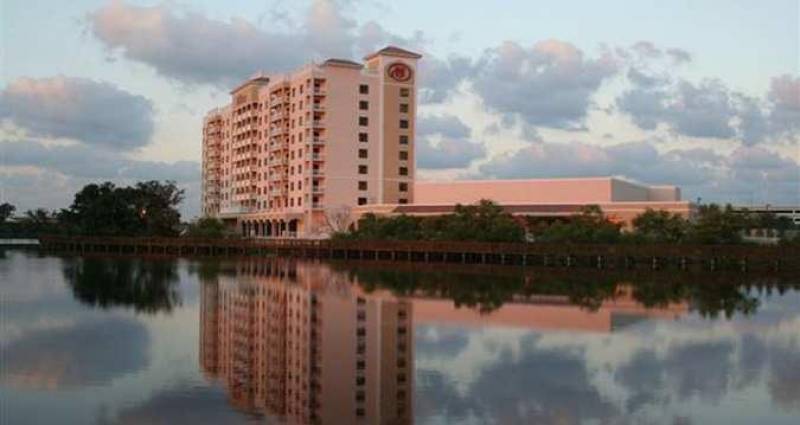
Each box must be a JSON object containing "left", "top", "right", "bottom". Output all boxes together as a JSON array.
[{"left": 0, "top": 181, "right": 184, "bottom": 237}]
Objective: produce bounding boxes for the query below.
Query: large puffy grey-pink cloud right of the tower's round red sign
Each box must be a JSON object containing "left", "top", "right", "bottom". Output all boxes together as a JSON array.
[{"left": 473, "top": 40, "right": 618, "bottom": 129}]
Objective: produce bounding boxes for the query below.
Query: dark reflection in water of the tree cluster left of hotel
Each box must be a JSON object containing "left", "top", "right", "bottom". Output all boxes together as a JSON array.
[{"left": 63, "top": 258, "right": 181, "bottom": 314}]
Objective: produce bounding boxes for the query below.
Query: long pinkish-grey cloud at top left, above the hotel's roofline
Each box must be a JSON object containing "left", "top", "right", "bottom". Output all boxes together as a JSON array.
[{"left": 88, "top": 1, "right": 324, "bottom": 86}]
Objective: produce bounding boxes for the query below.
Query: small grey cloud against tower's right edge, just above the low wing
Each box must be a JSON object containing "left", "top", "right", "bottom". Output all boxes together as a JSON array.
[{"left": 416, "top": 115, "right": 486, "bottom": 169}]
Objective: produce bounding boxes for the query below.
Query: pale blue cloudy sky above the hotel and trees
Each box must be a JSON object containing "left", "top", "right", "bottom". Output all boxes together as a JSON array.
[{"left": 0, "top": 0, "right": 800, "bottom": 218}]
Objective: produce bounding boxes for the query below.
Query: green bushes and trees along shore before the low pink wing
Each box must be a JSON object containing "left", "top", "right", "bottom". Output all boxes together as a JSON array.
[{"left": 334, "top": 201, "right": 800, "bottom": 244}]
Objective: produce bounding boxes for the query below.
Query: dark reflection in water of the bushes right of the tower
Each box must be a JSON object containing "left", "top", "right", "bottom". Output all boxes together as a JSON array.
[{"left": 349, "top": 269, "right": 800, "bottom": 318}]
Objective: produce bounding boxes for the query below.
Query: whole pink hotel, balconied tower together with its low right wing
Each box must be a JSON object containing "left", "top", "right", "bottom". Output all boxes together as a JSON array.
[{"left": 202, "top": 46, "right": 690, "bottom": 237}]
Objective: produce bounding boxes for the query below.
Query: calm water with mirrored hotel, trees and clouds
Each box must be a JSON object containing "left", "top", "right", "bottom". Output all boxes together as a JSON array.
[{"left": 0, "top": 250, "right": 800, "bottom": 424}]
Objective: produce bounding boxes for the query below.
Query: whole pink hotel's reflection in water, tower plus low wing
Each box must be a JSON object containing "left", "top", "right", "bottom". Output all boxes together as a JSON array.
[{"left": 200, "top": 259, "right": 689, "bottom": 424}]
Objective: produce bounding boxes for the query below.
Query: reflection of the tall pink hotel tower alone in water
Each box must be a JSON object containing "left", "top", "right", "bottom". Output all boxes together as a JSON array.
[{"left": 200, "top": 260, "right": 414, "bottom": 424}]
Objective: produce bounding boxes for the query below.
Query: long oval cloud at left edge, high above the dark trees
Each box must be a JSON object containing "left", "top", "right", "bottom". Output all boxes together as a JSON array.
[{"left": 0, "top": 76, "right": 154, "bottom": 150}]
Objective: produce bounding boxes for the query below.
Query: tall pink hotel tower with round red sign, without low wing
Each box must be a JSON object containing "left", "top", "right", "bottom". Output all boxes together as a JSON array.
[{"left": 202, "top": 46, "right": 421, "bottom": 237}]
